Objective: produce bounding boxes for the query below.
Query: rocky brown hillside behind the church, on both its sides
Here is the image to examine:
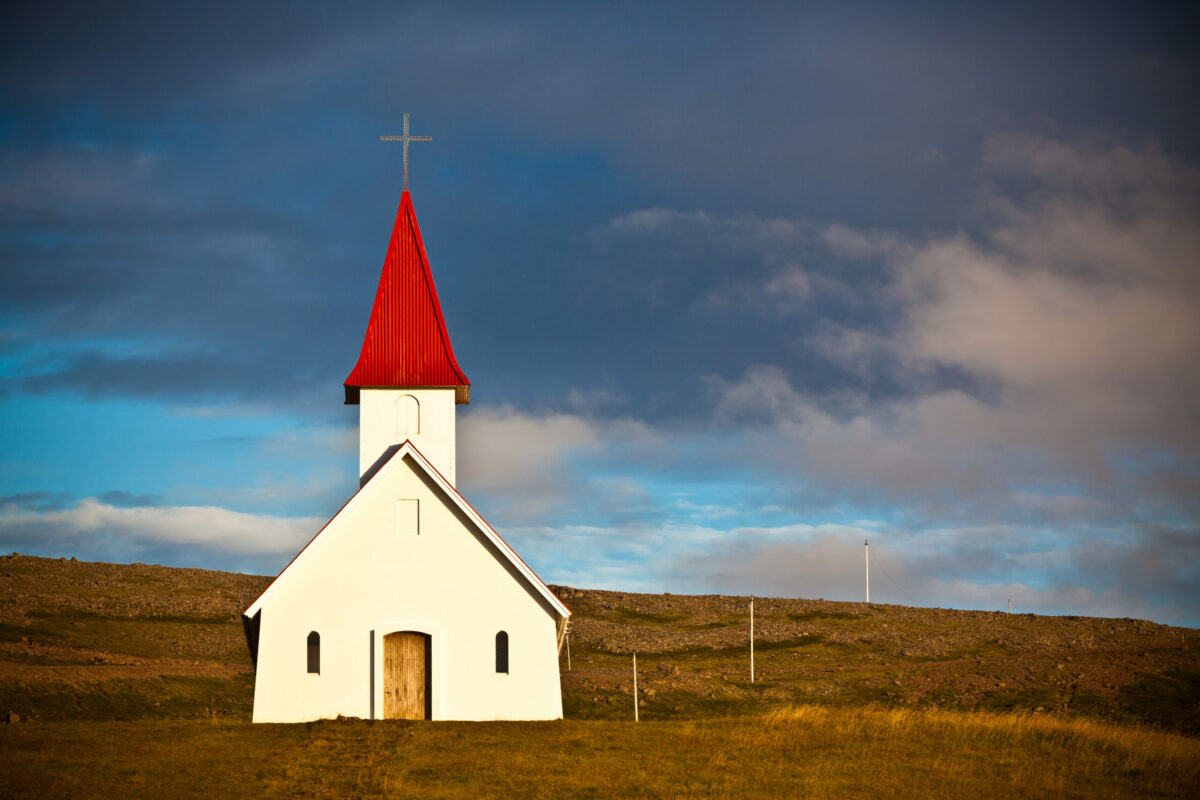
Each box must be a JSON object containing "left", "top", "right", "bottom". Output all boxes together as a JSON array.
[{"left": 0, "top": 554, "right": 1200, "bottom": 735}]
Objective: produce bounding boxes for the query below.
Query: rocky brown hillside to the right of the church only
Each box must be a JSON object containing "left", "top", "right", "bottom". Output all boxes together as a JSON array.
[{"left": 554, "top": 587, "right": 1200, "bottom": 733}]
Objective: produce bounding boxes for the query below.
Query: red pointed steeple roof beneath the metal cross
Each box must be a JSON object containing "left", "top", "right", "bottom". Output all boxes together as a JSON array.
[{"left": 344, "top": 191, "right": 470, "bottom": 404}]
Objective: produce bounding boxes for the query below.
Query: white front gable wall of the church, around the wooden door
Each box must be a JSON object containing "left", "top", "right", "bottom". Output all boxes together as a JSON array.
[{"left": 254, "top": 450, "right": 563, "bottom": 722}]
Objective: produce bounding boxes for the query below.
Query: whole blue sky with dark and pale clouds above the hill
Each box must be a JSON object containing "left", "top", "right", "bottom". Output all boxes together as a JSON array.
[{"left": 0, "top": 2, "right": 1200, "bottom": 625}]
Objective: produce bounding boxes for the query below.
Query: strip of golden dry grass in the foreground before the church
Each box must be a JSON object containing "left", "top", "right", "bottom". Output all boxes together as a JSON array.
[{"left": 0, "top": 705, "right": 1200, "bottom": 800}]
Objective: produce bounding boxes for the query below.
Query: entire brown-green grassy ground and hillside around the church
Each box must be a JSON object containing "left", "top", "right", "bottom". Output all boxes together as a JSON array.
[{"left": 0, "top": 557, "right": 1200, "bottom": 798}]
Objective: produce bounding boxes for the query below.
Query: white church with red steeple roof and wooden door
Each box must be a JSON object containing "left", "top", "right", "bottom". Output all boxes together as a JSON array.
[{"left": 242, "top": 172, "right": 570, "bottom": 722}]
